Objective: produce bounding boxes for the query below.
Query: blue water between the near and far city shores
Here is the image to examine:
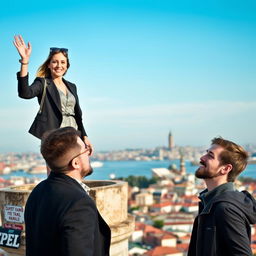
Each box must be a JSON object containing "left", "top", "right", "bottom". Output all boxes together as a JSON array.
[{"left": 0, "top": 160, "right": 256, "bottom": 180}]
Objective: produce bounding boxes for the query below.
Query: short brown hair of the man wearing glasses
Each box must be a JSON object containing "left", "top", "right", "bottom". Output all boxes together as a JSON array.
[{"left": 41, "top": 127, "right": 80, "bottom": 172}]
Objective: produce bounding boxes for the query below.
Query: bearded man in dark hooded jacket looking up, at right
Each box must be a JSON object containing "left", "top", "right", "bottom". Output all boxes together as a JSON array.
[{"left": 188, "top": 138, "right": 256, "bottom": 256}]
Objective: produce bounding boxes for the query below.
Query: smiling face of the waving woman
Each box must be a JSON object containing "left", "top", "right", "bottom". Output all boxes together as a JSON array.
[{"left": 48, "top": 52, "right": 68, "bottom": 79}]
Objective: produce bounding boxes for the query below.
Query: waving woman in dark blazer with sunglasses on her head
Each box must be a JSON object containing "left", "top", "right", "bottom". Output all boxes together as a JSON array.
[{"left": 13, "top": 35, "right": 93, "bottom": 155}]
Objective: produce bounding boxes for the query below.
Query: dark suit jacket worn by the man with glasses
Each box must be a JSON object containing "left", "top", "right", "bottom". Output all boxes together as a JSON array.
[{"left": 25, "top": 172, "right": 110, "bottom": 256}]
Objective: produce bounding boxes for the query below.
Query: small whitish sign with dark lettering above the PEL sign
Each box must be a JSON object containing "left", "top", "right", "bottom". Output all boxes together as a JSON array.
[{"left": 4, "top": 205, "right": 24, "bottom": 223}]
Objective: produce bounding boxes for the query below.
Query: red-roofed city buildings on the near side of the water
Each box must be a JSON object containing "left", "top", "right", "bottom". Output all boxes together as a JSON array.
[{"left": 125, "top": 157, "right": 256, "bottom": 256}]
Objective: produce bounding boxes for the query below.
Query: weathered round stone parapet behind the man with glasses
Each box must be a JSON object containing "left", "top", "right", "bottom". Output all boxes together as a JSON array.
[{"left": 0, "top": 180, "right": 134, "bottom": 256}]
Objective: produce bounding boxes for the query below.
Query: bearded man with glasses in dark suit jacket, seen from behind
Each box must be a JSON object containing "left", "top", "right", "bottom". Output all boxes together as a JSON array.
[{"left": 25, "top": 127, "right": 110, "bottom": 256}]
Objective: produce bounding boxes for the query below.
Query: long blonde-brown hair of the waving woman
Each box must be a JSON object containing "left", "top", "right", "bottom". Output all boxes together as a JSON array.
[{"left": 36, "top": 48, "right": 70, "bottom": 78}]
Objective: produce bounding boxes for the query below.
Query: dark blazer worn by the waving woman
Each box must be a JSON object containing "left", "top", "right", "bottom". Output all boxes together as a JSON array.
[{"left": 17, "top": 73, "right": 87, "bottom": 139}]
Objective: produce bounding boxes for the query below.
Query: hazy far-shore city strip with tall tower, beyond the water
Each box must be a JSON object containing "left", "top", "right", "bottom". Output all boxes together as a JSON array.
[{"left": 0, "top": 132, "right": 256, "bottom": 177}]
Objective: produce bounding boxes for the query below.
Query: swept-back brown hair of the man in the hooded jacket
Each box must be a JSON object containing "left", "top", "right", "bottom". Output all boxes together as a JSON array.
[{"left": 212, "top": 137, "right": 248, "bottom": 182}]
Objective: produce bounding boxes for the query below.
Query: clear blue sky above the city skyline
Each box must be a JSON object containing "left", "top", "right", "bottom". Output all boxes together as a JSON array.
[{"left": 0, "top": 0, "right": 256, "bottom": 152}]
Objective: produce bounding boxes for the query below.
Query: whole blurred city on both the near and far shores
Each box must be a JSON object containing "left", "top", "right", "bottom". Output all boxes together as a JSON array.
[{"left": 0, "top": 132, "right": 256, "bottom": 256}]
